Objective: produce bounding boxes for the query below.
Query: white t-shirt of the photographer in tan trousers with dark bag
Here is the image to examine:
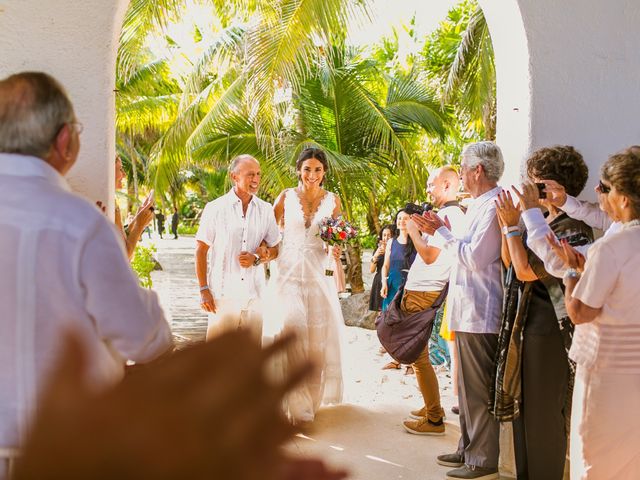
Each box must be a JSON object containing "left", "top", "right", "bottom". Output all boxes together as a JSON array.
[{"left": 404, "top": 205, "right": 465, "bottom": 292}]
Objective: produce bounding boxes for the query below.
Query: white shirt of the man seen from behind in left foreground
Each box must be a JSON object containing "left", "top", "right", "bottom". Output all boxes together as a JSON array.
[{"left": 0, "top": 154, "right": 172, "bottom": 450}]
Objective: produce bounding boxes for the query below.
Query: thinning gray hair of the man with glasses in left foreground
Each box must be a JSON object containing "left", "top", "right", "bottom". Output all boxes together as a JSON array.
[{"left": 0, "top": 72, "right": 75, "bottom": 158}]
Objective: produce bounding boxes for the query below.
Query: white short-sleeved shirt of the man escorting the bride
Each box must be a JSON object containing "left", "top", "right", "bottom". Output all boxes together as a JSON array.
[{"left": 196, "top": 189, "right": 280, "bottom": 301}]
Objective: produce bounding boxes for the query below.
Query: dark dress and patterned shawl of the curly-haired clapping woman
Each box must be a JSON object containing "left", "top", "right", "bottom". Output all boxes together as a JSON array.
[{"left": 490, "top": 213, "right": 593, "bottom": 480}]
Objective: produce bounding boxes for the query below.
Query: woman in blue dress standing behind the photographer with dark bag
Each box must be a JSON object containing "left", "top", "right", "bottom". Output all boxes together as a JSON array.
[{"left": 380, "top": 210, "right": 416, "bottom": 374}]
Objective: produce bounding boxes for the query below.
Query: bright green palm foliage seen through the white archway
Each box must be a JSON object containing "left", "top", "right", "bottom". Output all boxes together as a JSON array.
[{"left": 116, "top": 0, "right": 495, "bottom": 290}]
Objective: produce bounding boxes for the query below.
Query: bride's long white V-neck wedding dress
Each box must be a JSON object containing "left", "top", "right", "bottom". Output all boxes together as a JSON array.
[{"left": 264, "top": 189, "right": 344, "bottom": 423}]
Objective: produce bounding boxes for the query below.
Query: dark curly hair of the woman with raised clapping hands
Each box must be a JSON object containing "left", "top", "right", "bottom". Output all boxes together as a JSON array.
[{"left": 527, "top": 145, "right": 589, "bottom": 197}]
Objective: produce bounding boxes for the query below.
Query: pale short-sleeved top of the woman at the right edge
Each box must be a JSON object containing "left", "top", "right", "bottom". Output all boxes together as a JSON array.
[{"left": 570, "top": 226, "right": 640, "bottom": 374}]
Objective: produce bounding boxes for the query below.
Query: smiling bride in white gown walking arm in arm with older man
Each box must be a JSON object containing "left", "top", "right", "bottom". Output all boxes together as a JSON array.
[{"left": 270, "top": 148, "right": 344, "bottom": 423}]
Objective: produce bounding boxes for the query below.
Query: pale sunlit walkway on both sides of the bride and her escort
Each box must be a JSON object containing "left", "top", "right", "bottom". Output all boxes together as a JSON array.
[{"left": 144, "top": 237, "right": 516, "bottom": 480}]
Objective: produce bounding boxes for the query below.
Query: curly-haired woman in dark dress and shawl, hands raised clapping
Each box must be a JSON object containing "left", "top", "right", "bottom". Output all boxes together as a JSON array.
[{"left": 491, "top": 145, "right": 593, "bottom": 480}]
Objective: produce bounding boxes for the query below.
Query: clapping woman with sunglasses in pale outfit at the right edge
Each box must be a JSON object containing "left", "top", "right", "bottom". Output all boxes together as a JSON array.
[{"left": 549, "top": 147, "right": 640, "bottom": 480}]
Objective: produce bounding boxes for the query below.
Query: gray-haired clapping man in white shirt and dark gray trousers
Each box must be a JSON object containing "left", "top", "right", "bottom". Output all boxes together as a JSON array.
[{"left": 425, "top": 142, "right": 504, "bottom": 480}]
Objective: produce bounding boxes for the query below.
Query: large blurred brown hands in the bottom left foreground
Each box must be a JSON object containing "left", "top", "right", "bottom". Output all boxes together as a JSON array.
[{"left": 15, "top": 331, "right": 345, "bottom": 480}]
